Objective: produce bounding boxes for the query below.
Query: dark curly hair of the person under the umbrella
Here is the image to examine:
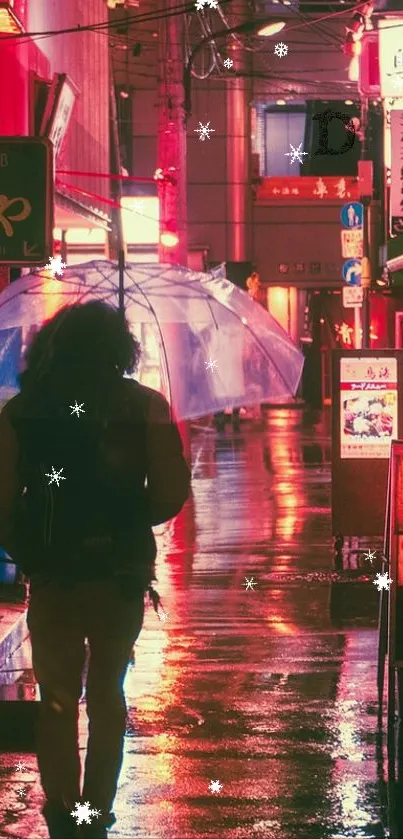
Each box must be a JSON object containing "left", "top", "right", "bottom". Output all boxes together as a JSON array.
[{"left": 19, "top": 300, "right": 141, "bottom": 391}]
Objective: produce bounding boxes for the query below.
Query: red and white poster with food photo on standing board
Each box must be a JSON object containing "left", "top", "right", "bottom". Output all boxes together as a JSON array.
[{"left": 340, "top": 358, "right": 398, "bottom": 459}]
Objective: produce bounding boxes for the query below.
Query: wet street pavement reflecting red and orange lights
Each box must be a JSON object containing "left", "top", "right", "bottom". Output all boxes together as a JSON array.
[{"left": 0, "top": 409, "right": 403, "bottom": 839}]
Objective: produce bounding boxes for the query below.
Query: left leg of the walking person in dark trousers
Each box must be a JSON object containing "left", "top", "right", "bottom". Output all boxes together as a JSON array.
[{"left": 27, "top": 583, "right": 84, "bottom": 816}]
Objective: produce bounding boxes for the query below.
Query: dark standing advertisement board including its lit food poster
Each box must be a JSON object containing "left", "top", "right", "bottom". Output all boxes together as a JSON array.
[{"left": 331, "top": 349, "right": 403, "bottom": 537}]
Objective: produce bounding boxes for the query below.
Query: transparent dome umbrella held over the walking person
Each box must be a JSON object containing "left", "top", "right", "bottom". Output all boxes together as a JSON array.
[{"left": 0, "top": 260, "right": 303, "bottom": 419}]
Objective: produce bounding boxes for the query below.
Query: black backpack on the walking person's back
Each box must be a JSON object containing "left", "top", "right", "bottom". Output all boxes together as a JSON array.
[{"left": 5, "top": 380, "right": 155, "bottom": 577}]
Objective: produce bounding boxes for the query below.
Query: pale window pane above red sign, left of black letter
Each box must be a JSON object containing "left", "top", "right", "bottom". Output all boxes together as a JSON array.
[{"left": 264, "top": 105, "right": 306, "bottom": 177}]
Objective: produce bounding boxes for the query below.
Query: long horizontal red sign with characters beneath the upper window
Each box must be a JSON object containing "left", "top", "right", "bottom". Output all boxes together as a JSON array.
[{"left": 256, "top": 175, "right": 360, "bottom": 203}]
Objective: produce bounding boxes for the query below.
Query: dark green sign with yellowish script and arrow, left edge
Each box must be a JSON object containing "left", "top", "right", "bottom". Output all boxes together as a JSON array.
[{"left": 0, "top": 137, "right": 53, "bottom": 265}]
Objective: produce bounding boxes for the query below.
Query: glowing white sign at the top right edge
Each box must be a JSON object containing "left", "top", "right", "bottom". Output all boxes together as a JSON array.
[{"left": 378, "top": 17, "right": 403, "bottom": 99}]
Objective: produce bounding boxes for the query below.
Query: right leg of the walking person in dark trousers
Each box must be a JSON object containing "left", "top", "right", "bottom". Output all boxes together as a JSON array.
[{"left": 82, "top": 580, "right": 144, "bottom": 825}]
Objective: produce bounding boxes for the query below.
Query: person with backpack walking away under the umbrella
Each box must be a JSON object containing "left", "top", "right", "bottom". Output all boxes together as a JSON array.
[{"left": 0, "top": 301, "right": 190, "bottom": 839}]
